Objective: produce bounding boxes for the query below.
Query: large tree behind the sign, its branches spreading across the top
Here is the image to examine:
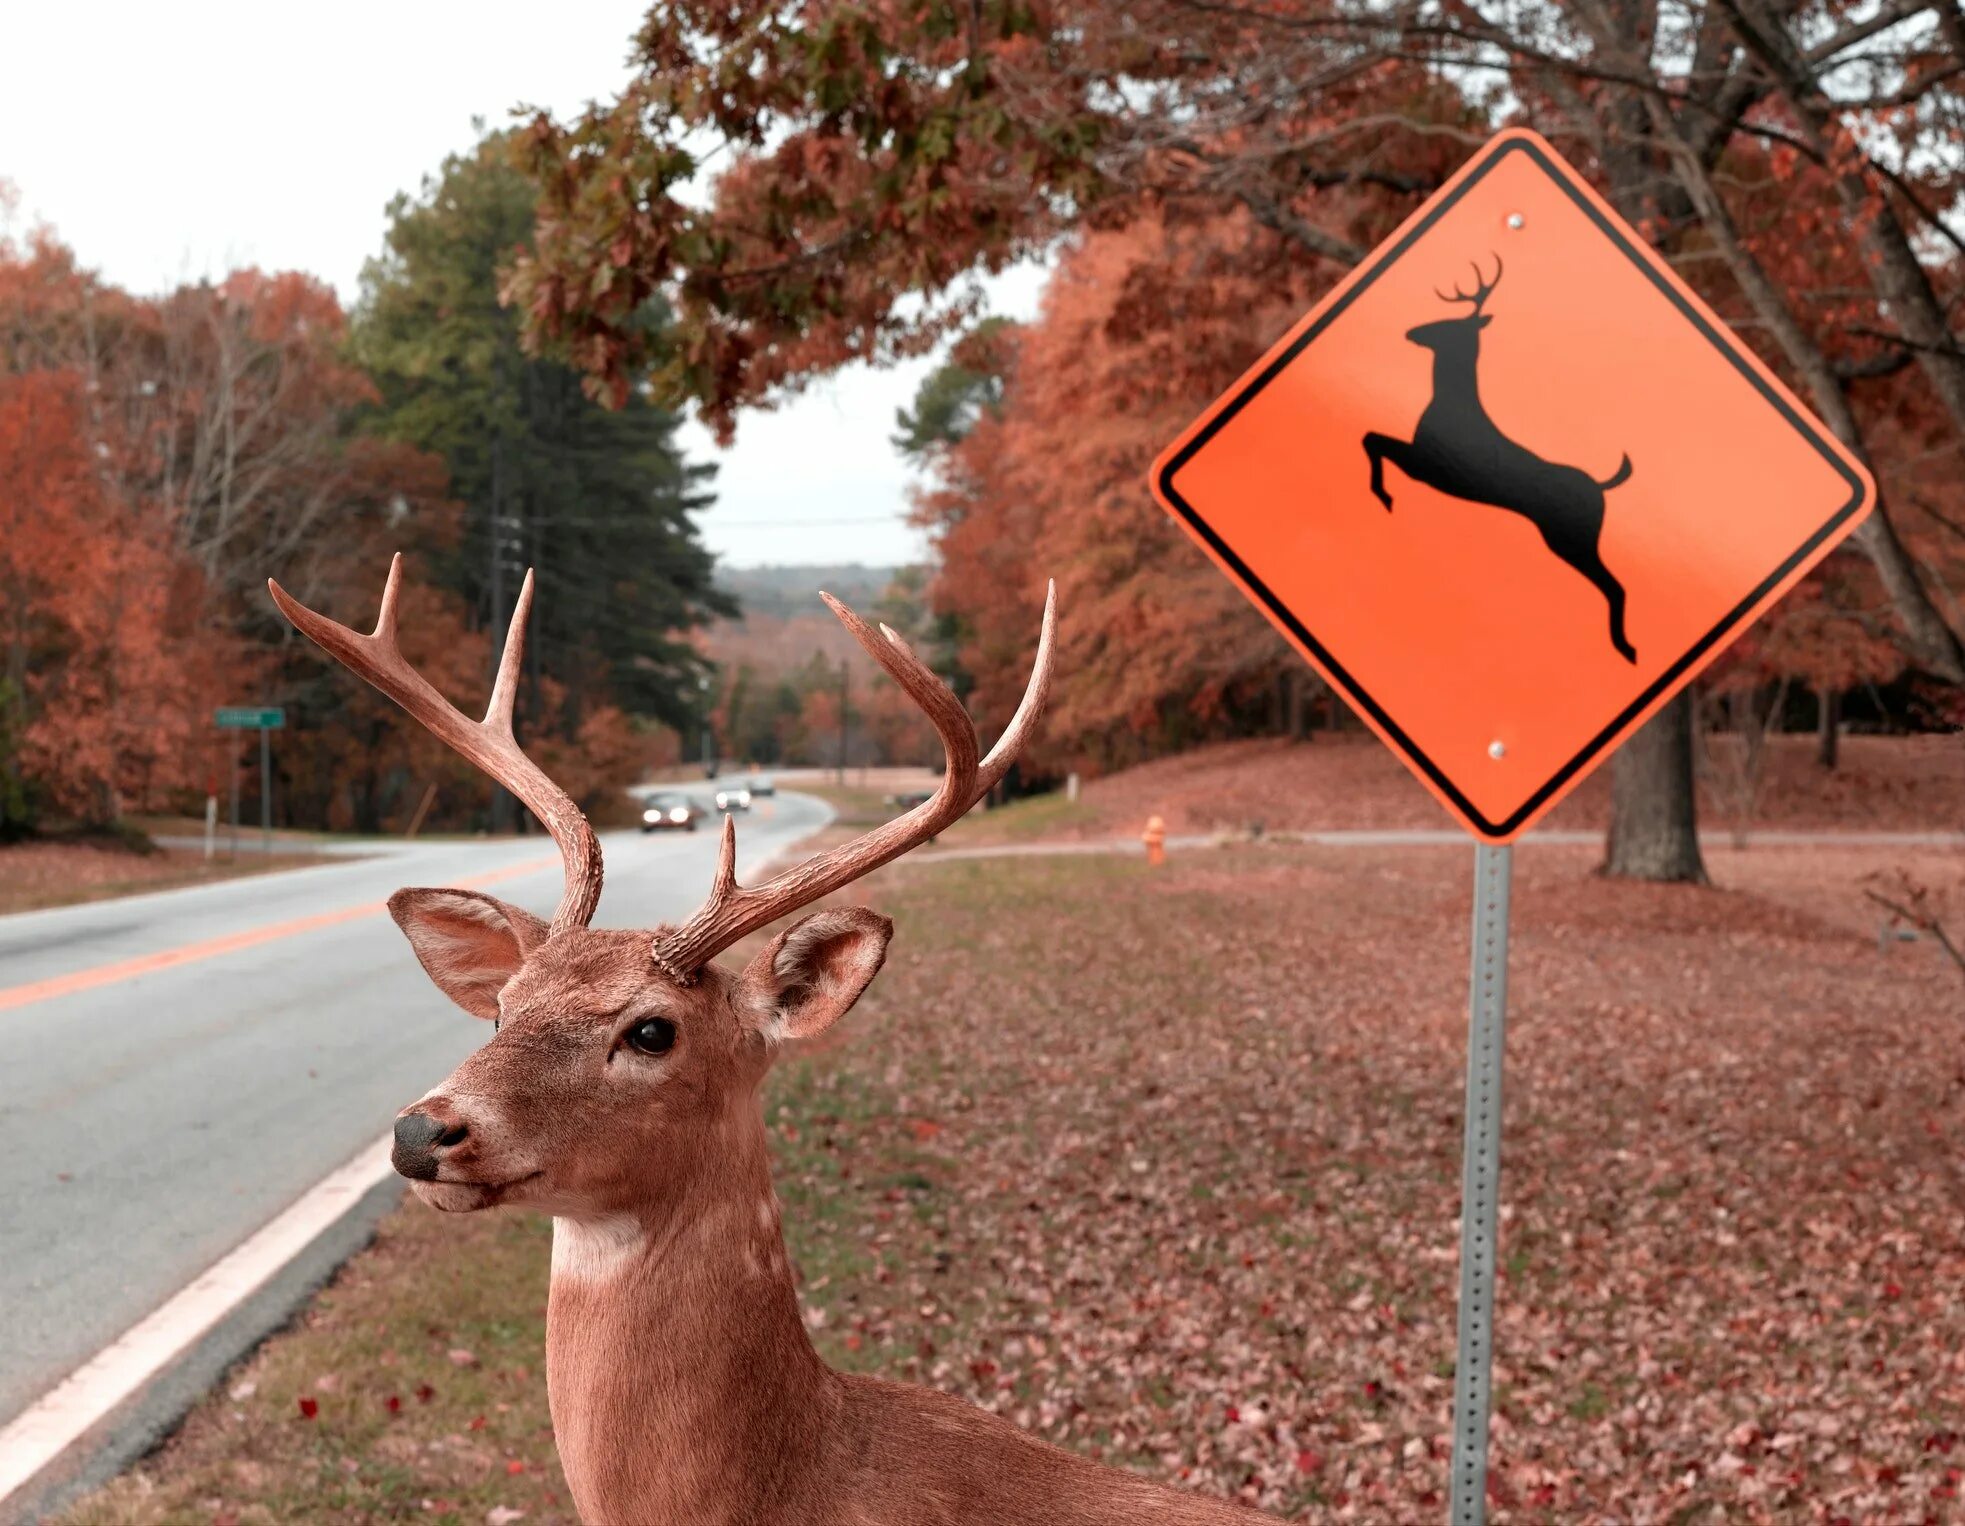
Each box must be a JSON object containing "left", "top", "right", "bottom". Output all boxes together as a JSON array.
[{"left": 513, "top": 0, "right": 1965, "bottom": 878}]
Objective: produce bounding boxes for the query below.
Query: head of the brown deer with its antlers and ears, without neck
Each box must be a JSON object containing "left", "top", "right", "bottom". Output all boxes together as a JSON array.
[{"left": 269, "top": 558, "right": 1055, "bottom": 1222}]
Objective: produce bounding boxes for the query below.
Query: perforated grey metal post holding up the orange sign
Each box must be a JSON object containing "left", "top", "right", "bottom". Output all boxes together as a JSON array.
[{"left": 1448, "top": 843, "right": 1513, "bottom": 1526}]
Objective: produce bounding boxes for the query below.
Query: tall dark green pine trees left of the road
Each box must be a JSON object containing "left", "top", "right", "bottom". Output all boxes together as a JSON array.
[{"left": 352, "top": 136, "right": 733, "bottom": 820}]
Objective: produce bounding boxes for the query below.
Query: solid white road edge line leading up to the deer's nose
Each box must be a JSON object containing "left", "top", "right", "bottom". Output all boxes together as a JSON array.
[{"left": 0, "top": 1135, "right": 391, "bottom": 1504}]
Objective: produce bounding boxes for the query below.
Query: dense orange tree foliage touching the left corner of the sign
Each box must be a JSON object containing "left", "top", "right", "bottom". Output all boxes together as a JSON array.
[{"left": 918, "top": 214, "right": 1322, "bottom": 762}]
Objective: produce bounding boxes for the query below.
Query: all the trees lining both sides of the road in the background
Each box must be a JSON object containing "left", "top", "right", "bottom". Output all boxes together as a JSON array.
[{"left": 0, "top": 0, "right": 1965, "bottom": 856}]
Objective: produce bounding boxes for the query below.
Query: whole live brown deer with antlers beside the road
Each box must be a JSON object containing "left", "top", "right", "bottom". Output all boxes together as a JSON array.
[{"left": 271, "top": 558, "right": 1252, "bottom": 1526}]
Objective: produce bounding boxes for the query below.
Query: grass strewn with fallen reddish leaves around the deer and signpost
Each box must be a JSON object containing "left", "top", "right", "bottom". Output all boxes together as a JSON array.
[{"left": 71, "top": 846, "right": 1965, "bottom": 1526}]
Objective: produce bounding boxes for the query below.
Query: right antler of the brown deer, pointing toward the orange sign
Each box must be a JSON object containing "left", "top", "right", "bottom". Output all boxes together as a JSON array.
[{"left": 650, "top": 583, "right": 1057, "bottom": 986}]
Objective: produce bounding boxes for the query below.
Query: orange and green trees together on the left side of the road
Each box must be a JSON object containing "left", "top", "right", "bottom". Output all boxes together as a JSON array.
[{"left": 0, "top": 136, "right": 735, "bottom": 841}]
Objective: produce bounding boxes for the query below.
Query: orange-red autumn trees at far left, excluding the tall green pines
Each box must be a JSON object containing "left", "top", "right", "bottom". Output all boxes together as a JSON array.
[{"left": 0, "top": 219, "right": 476, "bottom": 823}]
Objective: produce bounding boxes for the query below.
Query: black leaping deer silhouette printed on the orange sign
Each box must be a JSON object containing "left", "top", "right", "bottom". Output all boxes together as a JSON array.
[{"left": 1364, "top": 255, "right": 1637, "bottom": 662}]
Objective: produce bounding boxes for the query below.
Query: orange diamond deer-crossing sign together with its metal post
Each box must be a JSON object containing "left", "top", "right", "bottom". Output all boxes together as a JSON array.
[{"left": 1151, "top": 130, "right": 1875, "bottom": 1526}]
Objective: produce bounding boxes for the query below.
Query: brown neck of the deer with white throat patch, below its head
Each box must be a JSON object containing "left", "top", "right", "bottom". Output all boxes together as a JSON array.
[{"left": 546, "top": 1104, "right": 841, "bottom": 1526}]
